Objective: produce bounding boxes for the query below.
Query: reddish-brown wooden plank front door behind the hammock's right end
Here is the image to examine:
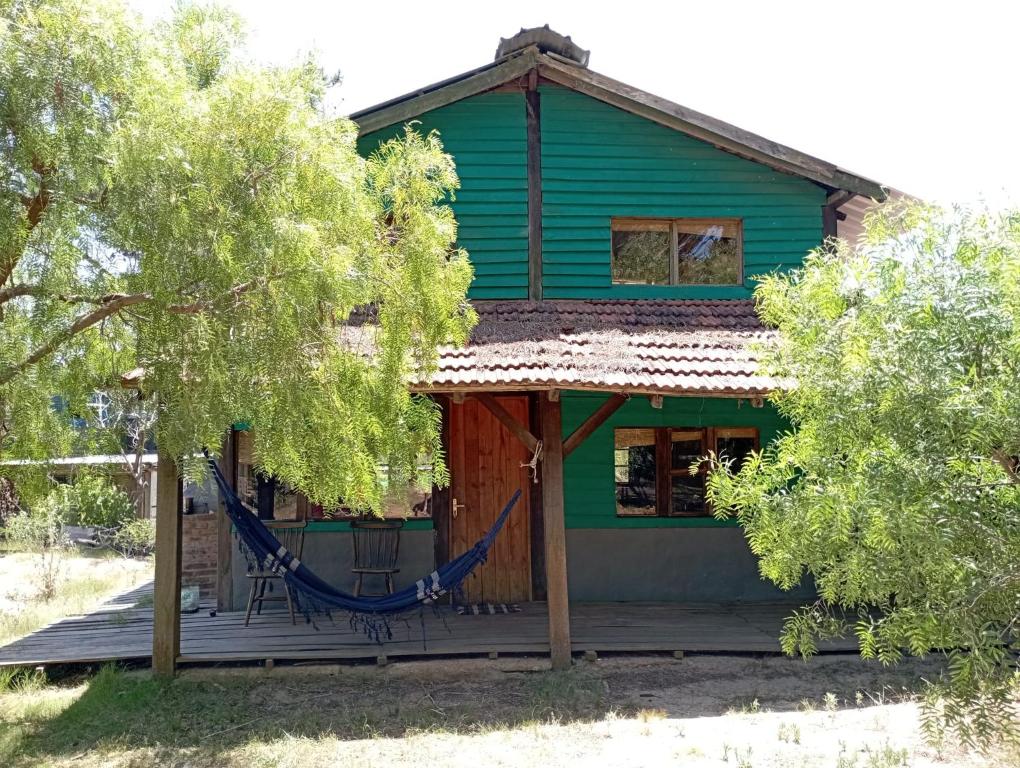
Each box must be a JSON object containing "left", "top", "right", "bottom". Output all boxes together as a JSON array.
[{"left": 450, "top": 396, "right": 531, "bottom": 603}]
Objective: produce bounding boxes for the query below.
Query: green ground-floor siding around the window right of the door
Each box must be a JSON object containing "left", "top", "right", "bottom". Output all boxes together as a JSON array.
[{"left": 560, "top": 392, "right": 786, "bottom": 528}]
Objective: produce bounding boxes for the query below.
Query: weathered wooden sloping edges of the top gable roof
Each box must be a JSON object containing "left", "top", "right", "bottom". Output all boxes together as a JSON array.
[{"left": 350, "top": 45, "right": 886, "bottom": 201}]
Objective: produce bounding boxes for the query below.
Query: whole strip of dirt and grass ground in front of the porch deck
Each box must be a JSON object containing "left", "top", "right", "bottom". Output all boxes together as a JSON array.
[{"left": 0, "top": 656, "right": 1020, "bottom": 768}]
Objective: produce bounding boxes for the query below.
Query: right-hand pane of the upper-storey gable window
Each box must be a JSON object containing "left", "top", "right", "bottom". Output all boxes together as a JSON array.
[{"left": 676, "top": 219, "right": 741, "bottom": 285}]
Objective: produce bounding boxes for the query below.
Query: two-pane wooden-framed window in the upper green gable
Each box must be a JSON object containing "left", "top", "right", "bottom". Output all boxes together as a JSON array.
[{"left": 612, "top": 218, "right": 744, "bottom": 286}]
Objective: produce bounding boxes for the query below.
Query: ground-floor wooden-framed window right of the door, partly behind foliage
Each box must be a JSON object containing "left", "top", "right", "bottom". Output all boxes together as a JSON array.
[{"left": 613, "top": 426, "right": 759, "bottom": 517}]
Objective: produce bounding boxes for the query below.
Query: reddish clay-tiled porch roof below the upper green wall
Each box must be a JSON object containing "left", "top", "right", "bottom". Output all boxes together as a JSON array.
[{"left": 415, "top": 299, "right": 779, "bottom": 397}]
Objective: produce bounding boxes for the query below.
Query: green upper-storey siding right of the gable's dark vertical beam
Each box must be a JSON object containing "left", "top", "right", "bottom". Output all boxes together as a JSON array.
[{"left": 542, "top": 86, "right": 825, "bottom": 297}]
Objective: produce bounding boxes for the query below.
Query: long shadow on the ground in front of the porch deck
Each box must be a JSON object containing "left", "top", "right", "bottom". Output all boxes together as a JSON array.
[{"left": 0, "top": 656, "right": 939, "bottom": 766}]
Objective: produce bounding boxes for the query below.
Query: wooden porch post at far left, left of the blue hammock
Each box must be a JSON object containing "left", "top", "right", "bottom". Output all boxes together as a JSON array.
[{"left": 152, "top": 451, "right": 183, "bottom": 677}]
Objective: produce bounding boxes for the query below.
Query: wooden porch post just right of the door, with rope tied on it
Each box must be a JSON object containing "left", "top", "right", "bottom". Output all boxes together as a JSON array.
[{"left": 539, "top": 393, "right": 570, "bottom": 669}]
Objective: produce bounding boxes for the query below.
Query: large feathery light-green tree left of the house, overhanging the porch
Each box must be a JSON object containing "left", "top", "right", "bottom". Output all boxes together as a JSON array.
[{"left": 0, "top": 0, "right": 472, "bottom": 508}]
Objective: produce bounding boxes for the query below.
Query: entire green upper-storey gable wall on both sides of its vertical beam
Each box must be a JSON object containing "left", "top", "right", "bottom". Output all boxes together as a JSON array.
[{"left": 359, "top": 86, "right": 825, "bottom": 299}]
